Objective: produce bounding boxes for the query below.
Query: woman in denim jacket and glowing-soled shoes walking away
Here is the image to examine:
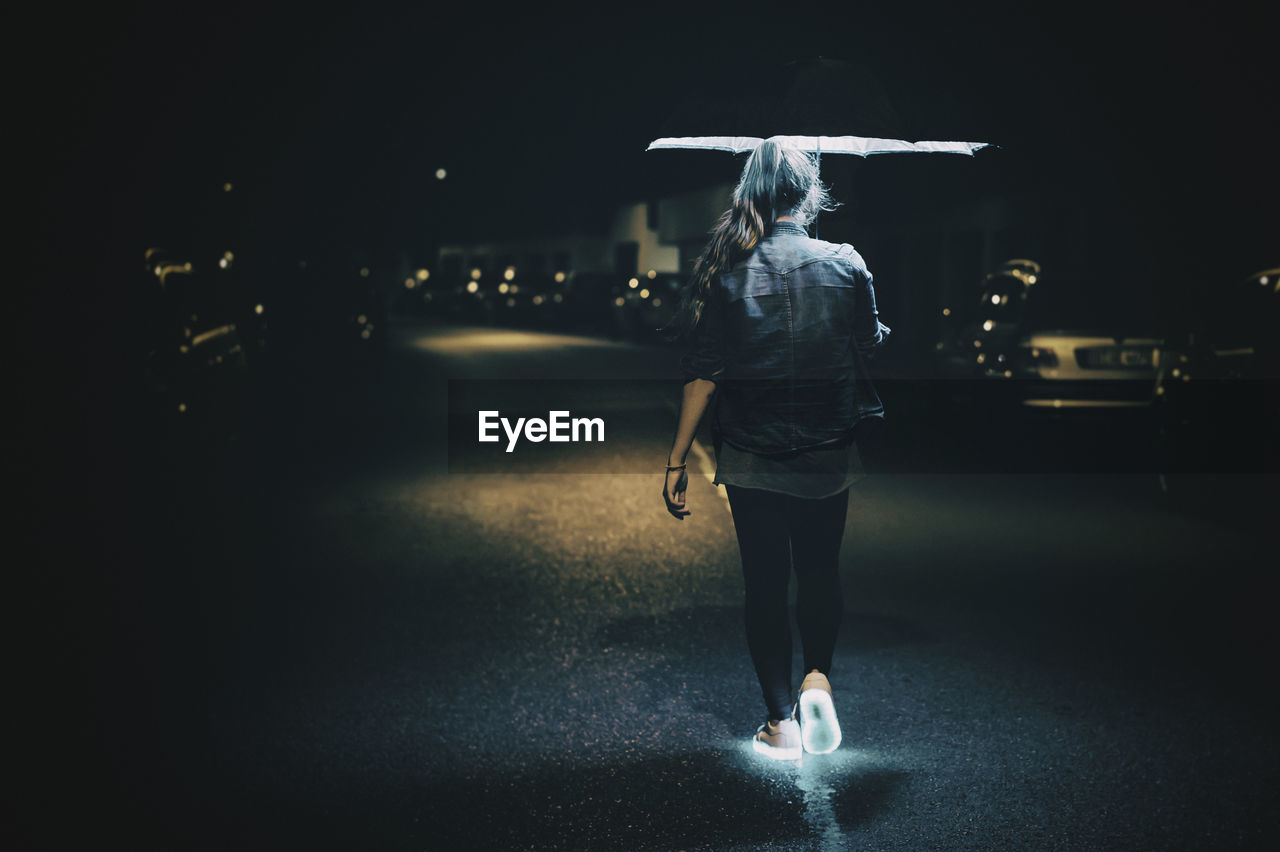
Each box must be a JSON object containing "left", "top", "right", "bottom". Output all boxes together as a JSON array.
[{"left": 663, "top": 138, "right": 890, "bottom": 760}]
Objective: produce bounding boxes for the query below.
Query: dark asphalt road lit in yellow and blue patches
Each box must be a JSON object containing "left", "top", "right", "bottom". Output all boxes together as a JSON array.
[{"left": 17, "top": 314, "right": 1280, "bottom": 849}]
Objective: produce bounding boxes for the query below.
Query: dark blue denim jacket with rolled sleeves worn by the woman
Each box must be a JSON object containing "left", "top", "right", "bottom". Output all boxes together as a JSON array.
[{"left": 681, "top": 221, "right": 890, "bottom": 455}]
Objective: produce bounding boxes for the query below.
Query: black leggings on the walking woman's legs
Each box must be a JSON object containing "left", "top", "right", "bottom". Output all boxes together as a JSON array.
[{"left": 724, "top": 482, "right": 849, "bottom": 719}]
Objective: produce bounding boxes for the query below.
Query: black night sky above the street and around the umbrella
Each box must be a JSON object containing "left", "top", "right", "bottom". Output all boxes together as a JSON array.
[{"left": 15, "top": 3, "right": 1276, "bottom": 275}]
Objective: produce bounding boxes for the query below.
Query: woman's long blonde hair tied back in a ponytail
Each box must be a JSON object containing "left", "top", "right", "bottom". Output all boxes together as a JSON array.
[{"left": 660, "top": 138, "right": 837, "bottom": 339}]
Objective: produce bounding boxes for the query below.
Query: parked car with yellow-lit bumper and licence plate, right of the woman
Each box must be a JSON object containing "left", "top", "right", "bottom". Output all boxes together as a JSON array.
[{"left": 933, "top": 258, "right": 1164, "bottom": 472}]
